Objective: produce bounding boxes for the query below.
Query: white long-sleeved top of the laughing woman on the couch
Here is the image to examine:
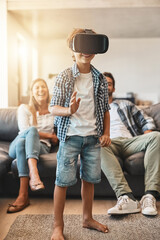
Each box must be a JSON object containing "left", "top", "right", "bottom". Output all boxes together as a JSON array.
[{"left": 18, "top": 104, "right": 54, "bottom": 147}]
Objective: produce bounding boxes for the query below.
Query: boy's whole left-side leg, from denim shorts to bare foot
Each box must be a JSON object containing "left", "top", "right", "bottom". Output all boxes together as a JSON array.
[{"left": 51, "top": 136, "right": 81, "bottom": 240}]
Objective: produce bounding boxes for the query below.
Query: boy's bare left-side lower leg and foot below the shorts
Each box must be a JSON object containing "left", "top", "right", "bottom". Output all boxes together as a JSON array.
[{"left": 51, "top": 185, "right": 67, "bottom": 240}]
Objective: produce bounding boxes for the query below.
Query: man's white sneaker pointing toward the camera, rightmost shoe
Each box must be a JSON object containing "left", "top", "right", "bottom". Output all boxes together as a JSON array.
[{"left": 140, "top": 194, "right": 157, "bottom": 216}]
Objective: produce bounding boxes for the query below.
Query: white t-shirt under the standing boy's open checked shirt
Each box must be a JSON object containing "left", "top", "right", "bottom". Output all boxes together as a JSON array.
[{"left": 67, "top": 72, "right": 97, "bottom": 136}]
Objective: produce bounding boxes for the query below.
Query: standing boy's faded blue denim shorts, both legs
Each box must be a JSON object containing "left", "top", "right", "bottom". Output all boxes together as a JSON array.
[{"left": 55, "top": 136, "right": 101, "bottom": 187}]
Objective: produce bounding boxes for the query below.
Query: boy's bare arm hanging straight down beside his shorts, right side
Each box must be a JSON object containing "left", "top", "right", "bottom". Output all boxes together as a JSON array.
[{"left": 99, "top": 111, "right": 111, "bottom": 147}]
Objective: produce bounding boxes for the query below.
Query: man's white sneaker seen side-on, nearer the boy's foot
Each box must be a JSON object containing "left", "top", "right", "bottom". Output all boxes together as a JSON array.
[{"left": 108, "top": 195, "right": 141, "bottom": 215}]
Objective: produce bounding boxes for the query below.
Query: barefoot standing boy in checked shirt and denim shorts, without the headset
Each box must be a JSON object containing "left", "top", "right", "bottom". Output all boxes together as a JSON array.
[{"left": 51, "top": 29, "right": 111, "bottom": 240}]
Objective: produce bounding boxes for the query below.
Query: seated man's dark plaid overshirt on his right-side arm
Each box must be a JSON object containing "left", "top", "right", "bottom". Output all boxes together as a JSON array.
[{"left": 112, "top": 100, "right": 156, "bottom": 137}]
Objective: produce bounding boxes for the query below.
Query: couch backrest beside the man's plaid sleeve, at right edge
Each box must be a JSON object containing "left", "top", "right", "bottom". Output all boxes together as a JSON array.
[{"left": 143, "top": 103, "right": 160, "bottom": 131}]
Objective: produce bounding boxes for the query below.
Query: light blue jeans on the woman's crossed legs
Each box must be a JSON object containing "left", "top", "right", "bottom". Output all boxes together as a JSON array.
[{"left": 9, "top": 127, "right": 50, "bottom": 177}]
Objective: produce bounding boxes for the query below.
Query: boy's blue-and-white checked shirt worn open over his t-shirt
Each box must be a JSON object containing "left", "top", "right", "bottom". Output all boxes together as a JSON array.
[{"left": 50, "top": 63, "right": 110, "bottom": 142}]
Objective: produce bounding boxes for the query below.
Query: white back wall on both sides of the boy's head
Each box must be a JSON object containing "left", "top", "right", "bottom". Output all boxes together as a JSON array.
[{"left": 39, "top": 38, "right": 160, "bottom": 103}]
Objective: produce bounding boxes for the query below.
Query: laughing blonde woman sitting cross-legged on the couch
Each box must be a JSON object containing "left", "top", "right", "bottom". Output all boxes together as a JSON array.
[{"left": 7, "top": 79, "right": 58, "bottom": 213}]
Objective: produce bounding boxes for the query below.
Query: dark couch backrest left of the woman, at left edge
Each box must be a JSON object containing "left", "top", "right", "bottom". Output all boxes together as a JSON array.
[{"left": 0, "top": 108, "right": 19, "bottom": 142}]
